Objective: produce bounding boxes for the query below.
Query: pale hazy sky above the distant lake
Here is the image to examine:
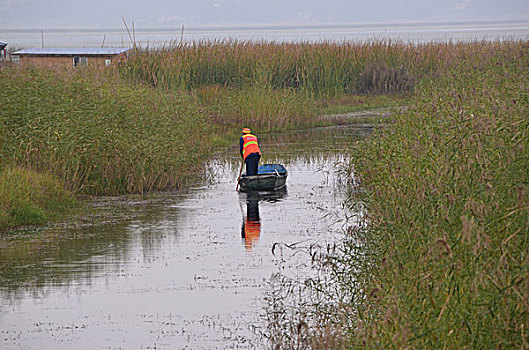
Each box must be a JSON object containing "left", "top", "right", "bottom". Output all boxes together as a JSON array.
[{"left": 0, "top": 0, "right": 529, "bottom": 29}]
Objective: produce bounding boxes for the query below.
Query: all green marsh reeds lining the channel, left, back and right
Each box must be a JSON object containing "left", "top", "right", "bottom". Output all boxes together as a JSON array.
[{"left": 0, "top": 37, "right": 529, "bottom": 348}]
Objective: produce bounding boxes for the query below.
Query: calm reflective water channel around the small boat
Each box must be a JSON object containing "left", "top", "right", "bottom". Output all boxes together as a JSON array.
[{"left": 0, "top": 127, "right": 369, "bottom": 349}]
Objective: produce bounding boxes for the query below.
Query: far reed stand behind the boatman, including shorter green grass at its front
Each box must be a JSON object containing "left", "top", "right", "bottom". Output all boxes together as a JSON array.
[{"left": 119, "top": 40, "right": 524, "bottom": 132}]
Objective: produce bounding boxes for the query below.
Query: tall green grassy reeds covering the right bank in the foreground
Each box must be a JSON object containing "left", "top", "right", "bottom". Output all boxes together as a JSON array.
[{"left": 268, "top": 43, "right": 529, "bottom": 349}]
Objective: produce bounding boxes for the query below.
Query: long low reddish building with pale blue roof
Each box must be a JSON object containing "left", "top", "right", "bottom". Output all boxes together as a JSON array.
[{"left": 12, "top": 47, "right": 131, "bottom": 67}]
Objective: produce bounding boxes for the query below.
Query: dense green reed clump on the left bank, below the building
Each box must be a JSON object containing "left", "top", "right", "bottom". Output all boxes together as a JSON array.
[{"left": 0, "top": 69, "right": 211, "bottom": 195}]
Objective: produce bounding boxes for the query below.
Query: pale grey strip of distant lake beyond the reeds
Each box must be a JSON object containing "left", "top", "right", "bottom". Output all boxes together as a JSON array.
[{"left": 0, "top": 21, "right": 529, "bottom": 48}]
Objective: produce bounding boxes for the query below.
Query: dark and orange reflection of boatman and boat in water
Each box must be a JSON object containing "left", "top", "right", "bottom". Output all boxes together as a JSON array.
[{"left": 240, "top": 188, "right": 287, "bottom": 251}]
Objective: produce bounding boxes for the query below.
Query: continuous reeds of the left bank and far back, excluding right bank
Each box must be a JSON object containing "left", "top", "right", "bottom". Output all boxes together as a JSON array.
[{"left": 0, "top": 41, "right": 521, "bottom": 232}]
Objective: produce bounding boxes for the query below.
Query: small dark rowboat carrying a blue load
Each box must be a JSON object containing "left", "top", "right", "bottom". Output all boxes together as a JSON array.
[{"left": 239, "top": 164, "right": 288, "bottom": 192}]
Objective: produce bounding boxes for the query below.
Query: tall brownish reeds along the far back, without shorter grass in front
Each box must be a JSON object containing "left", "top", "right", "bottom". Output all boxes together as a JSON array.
[{"left": 121, "top": 40, "right": 512, "bottom": 98}]
